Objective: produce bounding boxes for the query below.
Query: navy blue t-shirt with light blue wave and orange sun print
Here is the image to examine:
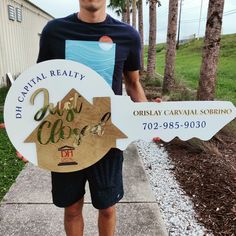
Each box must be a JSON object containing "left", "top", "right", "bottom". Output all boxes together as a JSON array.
[{"left": 37, "top": 13, "right": 141, "bottom": 95}]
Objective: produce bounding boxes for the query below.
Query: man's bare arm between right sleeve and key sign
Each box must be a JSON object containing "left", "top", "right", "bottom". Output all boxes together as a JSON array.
[{"left": 123, "top": 70, "right": 147, "bottom": 102}]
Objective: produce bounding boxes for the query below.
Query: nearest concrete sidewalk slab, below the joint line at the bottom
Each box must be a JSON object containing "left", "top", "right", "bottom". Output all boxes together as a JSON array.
[{"left": 0, "top": 203, "right": 164, "bottom": 236}]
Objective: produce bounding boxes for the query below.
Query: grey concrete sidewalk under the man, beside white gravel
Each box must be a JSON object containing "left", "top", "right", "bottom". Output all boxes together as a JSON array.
[{"left": 0, "top": 144, "right": 167, "bottom": 236}]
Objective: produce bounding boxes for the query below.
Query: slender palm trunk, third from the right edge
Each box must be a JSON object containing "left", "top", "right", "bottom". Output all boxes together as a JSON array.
[{"left": 147, "top": 0, "right": 157, "bottom": 79}]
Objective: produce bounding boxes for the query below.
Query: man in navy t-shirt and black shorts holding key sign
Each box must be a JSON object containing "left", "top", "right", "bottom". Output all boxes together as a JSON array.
[{"left": 38, "top": 0, "right": 147, "bottom": 236}]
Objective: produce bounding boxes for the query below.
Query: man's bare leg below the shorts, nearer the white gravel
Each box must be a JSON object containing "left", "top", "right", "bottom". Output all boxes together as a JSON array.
[{"left": 98, "top": 205, "right": 116, "bottom": 236}]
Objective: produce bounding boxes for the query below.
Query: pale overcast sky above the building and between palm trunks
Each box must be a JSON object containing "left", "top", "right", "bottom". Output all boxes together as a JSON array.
[{"left": 30, "top": 0, "right": 236, "bottom": 44}]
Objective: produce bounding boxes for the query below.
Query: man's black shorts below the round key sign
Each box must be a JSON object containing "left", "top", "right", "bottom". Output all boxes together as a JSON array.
[{"left": 51, "top": 148, "right": 124, "bottom": 209}]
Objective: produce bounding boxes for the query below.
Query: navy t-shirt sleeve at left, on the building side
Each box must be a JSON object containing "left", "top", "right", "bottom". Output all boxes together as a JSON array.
[{"left": 37, "top": 24, "right": 51, "bottom": 63}]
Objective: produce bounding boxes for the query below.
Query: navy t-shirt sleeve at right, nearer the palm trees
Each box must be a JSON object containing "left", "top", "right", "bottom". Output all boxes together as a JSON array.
[{"left": 124, "top": 31, "right": 141, "bottom": 71}]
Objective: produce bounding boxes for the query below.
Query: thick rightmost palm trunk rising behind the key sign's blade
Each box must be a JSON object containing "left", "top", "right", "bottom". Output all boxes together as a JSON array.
[{"left": 197, "top": 0, "right": 224, "bottom": 100}]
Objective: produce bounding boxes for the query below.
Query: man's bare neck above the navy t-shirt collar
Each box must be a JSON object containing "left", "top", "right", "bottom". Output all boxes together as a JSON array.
[{"left": 77, "top": 9, "right": 106, "bottom": 23}]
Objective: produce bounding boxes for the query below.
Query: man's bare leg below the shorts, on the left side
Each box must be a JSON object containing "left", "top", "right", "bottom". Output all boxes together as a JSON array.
[{"left": 64, "top": 198, "right": 84, "bottom": 236}]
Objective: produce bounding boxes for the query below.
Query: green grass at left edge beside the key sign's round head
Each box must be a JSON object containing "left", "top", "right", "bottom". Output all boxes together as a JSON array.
[{"left": 0, "top": 88, "right": 24, "bottom": 201}]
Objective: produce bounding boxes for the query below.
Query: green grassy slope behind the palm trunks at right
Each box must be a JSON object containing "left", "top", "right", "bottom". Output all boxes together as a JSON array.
[{"left": 145, "top": 34, "right": 236, "bottom": 104}]
